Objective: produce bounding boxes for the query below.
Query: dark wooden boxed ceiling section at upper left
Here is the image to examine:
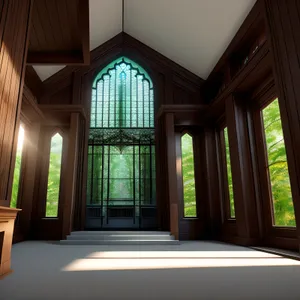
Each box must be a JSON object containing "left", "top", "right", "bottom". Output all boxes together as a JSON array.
[{"left": 27, "top": 0, "right": 90, "bottom": 65}]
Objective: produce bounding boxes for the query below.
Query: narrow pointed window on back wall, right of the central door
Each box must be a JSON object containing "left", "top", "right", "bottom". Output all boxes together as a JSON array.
[{"left": 181, "top": 134, "right": 197, "bottom": 217}]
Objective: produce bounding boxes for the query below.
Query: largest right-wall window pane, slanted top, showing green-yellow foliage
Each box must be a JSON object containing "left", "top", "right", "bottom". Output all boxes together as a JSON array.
[{"left": 262, "top": 99, "right": 296, "bottom": 226}]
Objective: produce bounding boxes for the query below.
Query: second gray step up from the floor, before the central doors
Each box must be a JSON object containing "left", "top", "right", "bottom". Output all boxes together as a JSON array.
[{"left": 67, "top": 234, "right": 174, "bottom": 241}]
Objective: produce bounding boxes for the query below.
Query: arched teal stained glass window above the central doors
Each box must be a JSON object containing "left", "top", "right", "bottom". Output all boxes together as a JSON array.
[{"left": 90, "top": 57, "right": 154, "bottom": 128}]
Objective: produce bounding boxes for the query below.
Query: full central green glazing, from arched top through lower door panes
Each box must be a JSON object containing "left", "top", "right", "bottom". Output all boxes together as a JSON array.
[{"left": 87, "top": 57, "right": 155, "bottom": 210}]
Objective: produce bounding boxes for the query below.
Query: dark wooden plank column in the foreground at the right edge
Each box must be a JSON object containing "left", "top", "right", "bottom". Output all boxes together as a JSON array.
[{"left": 264, "top": 0, "right": 300, "bottom": 244}]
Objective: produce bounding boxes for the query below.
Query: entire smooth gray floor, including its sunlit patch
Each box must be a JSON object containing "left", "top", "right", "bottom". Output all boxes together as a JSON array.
[{"left": 0, "top": 242, "right": 300, "bottom": 300}]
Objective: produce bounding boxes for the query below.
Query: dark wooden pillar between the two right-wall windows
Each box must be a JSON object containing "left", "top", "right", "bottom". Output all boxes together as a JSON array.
[{"left": 226, "top": 95, "right": 259, "bottom": 245}]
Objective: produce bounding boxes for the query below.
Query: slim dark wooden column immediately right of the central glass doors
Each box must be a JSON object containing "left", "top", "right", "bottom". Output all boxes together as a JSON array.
[{"left": 165, "top": 113, "right": 179, "bottom": 239}]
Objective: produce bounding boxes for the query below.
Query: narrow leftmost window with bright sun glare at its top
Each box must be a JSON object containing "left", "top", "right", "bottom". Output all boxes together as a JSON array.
[{"left": 10, "top": 125, "right": 25, "bottom": 208}]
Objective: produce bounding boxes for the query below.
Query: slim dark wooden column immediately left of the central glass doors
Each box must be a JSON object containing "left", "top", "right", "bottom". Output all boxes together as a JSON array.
[{"left": 62, "top": 113, "right": 80, "bottom": 238}]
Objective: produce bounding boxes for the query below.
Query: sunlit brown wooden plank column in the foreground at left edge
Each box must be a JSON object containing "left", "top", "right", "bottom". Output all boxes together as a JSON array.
[{"left": 0, "top": 0, "right": 32, "bottom": 206}]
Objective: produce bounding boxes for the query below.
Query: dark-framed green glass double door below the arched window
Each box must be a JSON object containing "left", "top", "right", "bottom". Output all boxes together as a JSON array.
[{"left": 86, "top": 145, "right": 156, "bottom": 229}]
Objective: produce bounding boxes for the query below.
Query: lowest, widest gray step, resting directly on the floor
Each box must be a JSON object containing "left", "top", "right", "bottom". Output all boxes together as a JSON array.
[{"left": 60, "top": 240, "right": 179, "bottom": 246}]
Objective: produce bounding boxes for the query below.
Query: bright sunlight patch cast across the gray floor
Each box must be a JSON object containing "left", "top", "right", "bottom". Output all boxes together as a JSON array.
[{"left": 62, "top": 251, "right": 300, "bottom": 271}]
